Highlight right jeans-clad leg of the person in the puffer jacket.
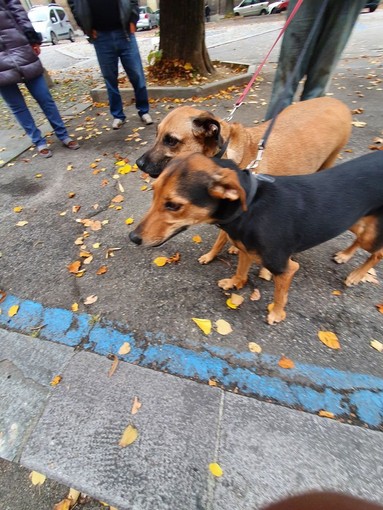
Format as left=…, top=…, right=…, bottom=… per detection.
left=25, top=75, right=69, bottom=142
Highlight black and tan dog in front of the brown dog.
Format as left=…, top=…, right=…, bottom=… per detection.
left=130, top=151, right=383, bottom=324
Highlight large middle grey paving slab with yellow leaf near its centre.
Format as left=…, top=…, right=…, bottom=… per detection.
left=21, top=352, right=222, bottom=510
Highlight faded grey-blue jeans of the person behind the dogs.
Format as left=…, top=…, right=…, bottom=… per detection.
left=265, top=0, right=366, bottom=120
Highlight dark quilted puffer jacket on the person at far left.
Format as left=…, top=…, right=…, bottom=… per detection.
left=0, top=0, right=44, bottom=87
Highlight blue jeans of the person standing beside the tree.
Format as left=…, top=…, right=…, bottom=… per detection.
left=93, top=30, right=149, bottom=120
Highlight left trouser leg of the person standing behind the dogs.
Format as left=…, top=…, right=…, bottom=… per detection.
left=265, top=0, right=321, bottom=120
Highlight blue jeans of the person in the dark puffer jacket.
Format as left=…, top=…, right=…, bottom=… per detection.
left=0, top=75, right=69, bottom=147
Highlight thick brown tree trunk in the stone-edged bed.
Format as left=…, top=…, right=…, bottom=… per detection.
left=160, top=0, right=215, bottom=76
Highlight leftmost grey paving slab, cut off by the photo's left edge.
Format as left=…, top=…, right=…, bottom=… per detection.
left=0, top=329, right=73, bottom=460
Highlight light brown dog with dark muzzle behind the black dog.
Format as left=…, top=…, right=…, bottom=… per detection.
left=137, top=97, right=352, bottom=268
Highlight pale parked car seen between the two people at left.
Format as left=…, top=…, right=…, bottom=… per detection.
left=28, top=4, right=74, bottom=44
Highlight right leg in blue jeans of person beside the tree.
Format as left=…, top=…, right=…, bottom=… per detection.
left=118, top=31, right=149, bottom=117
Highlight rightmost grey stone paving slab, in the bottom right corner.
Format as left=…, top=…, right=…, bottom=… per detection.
left=213, top=392, right=383, bottom=510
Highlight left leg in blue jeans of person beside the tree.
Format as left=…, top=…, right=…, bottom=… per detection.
left=94, top=31, right=126, bottom=121
